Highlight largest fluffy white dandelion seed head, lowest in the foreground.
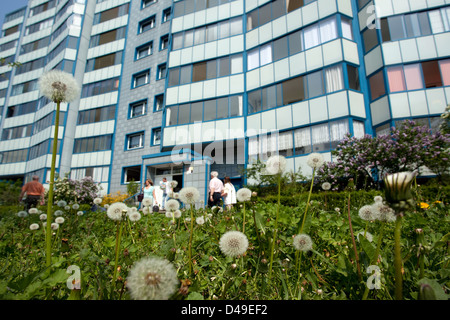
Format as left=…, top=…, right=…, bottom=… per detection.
left=126, top=257, right=179, bottom=300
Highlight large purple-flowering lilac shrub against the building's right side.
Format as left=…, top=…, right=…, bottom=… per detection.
left=316, top=120, right=450, bottom=190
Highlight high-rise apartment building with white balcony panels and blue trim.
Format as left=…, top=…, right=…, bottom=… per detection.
left=0, top=0, right=450, bottom=206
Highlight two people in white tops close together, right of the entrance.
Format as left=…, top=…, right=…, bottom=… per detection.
left=208, top=171, right=236, bottom=210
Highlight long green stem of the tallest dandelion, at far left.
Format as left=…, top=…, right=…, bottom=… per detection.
left=45, top=101, right=60, bottom=267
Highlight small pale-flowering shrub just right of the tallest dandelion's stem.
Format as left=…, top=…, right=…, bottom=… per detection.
left=54, top=176, right=101, bottom=204
